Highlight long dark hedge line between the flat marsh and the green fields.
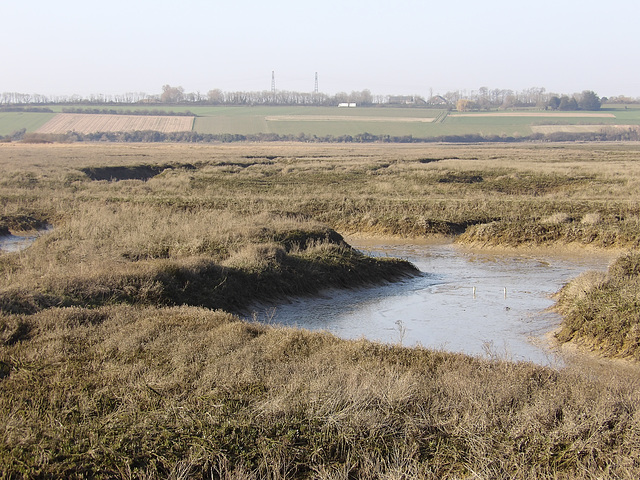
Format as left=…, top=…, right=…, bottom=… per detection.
left=11, top=127, right=640, bottom=143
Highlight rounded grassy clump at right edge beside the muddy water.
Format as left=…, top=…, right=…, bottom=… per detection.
left=557, top=253, right=640, bottom=361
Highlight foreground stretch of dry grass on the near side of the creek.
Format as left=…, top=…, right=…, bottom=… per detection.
left=0, top=305, right=640, bottom=479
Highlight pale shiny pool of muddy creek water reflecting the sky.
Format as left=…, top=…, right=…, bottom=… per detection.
left=246, top=242, right=607, bottom=364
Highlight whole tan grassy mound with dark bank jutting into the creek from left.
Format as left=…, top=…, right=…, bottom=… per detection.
left=0, top=207, right=418, bottom=313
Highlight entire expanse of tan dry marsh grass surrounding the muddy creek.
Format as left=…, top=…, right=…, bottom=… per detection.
left=0, top=144, right=640, bottom=479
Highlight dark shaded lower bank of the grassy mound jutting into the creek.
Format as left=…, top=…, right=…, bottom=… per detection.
left=0, top=243, right=418, bottom=313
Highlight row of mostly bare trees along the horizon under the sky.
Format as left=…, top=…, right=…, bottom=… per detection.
left=0, top=85, right=640, bottom=110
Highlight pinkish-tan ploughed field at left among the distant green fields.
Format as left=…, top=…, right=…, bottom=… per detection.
left=36, top=113, right=193, bottom=133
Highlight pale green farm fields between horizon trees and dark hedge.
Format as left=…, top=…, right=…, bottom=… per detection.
left=0, top=105, right=640, bottom=138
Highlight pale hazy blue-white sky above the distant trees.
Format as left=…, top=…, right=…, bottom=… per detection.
left=5, top=0, right=640, bottom=97
